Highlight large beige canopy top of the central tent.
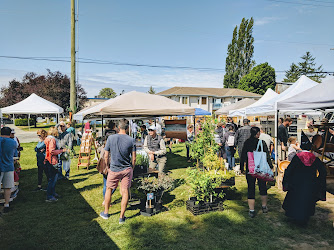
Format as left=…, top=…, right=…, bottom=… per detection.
left=74, top=91, right=195, bottom=120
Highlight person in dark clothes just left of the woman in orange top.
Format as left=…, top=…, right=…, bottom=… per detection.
left=34, top=129, right=48, bottom=191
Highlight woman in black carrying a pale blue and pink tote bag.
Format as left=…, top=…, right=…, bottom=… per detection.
left=240, top=127, right=274, bottom=218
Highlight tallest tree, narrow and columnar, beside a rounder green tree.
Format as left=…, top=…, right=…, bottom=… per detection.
left=224, top=17, right=255, bottom=88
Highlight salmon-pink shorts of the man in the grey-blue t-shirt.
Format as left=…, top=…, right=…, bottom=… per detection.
left=107, top=167, right=133, bottom=189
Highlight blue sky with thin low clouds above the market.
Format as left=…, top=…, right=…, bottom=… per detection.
left=0, top=0, right=334, bottom=97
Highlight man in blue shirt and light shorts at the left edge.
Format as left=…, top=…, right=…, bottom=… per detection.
left=0, top=127, right=17, bottom=213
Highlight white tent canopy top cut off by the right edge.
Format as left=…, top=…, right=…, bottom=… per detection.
left=277, top=79, right=334, bottom=111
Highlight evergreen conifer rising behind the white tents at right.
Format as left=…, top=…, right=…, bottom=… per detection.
left=283, top=51, right=326, bottom=82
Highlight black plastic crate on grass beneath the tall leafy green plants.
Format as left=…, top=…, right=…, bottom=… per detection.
left=186, top=197, right=224, bottom=215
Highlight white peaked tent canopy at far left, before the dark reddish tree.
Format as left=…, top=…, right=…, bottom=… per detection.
left=1, top=93, right=64, bottom=114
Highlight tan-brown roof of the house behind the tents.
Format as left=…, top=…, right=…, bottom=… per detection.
left=158, top=87, right=261, bottom=97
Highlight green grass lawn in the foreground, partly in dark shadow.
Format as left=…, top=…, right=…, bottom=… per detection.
left=0, top=143, right=334, bottom=249
